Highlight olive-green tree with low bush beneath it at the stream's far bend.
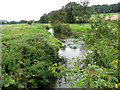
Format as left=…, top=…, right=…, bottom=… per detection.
left=49, top=7, right=71, bottom=34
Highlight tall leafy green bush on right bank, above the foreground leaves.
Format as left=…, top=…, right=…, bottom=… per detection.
left=85, top=16, right=118, bottom=68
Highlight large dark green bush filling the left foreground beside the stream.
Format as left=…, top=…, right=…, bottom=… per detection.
left=2, top=34, right=60, bottom=89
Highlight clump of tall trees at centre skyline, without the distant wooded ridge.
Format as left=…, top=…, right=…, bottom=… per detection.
left=40, top=2, right=90, bottom=23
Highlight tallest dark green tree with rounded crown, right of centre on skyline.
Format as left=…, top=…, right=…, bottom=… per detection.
left=65, top=0, right=90, bottom=23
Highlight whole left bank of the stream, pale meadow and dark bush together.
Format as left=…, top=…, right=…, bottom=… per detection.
left=2, top=24, right=61, bottom=89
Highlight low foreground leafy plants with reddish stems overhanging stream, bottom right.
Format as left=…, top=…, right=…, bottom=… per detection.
left=49, top=59, right=118, bottom=88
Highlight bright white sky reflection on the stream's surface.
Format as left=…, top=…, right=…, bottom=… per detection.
left=53, top=34, right=86, bottom=88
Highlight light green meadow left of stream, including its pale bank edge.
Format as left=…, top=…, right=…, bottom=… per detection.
left=2, top=24, right=59, bottom=44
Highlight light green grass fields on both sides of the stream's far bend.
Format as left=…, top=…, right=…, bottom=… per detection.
left=2, top=24, right=90, bottom=38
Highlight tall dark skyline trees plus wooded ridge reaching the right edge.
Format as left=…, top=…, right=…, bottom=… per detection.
left=39, top=2, right=120, bottom=23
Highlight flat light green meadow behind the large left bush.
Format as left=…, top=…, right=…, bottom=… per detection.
left=2, top=24, right=48, bottom=41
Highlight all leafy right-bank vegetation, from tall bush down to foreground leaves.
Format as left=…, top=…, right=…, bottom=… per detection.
left=50, top=16, right=120, bottom=88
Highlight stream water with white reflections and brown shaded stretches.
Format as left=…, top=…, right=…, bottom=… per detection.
left=48, top=29, right=90, bottom=88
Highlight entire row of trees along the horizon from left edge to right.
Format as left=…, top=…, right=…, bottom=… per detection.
left=0, top=2, right=120, bottom=24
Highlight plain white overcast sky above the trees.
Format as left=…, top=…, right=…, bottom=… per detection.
left=0, top=0, right=120, bottom=21
